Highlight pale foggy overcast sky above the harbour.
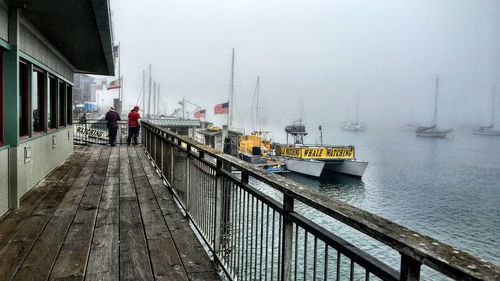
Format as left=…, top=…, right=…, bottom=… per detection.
left=104, top=0, right=500, bottom=129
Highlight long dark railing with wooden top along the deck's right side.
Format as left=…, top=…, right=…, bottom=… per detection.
left=142, top=122, right=500, bottom=280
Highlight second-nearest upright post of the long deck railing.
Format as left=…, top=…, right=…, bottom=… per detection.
left=281, top=194, right=294, bottom=281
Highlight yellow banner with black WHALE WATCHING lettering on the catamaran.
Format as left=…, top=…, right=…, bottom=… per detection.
left=276, top=147, right=354, bottom=159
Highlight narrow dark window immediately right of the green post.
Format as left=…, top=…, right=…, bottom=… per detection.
left=19, top=61, right=29, bottom=137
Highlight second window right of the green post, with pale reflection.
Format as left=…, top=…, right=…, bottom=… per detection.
left=31, top=68, right=46, bottom=133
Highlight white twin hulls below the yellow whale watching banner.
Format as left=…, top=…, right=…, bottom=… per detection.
left=285, top=159, right=368, bottom=177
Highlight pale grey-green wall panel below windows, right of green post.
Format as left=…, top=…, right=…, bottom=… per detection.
left=17, top=127, right=73, bottom=199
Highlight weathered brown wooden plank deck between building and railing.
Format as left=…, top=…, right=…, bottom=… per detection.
left=0, top=146, right=219, bottom=281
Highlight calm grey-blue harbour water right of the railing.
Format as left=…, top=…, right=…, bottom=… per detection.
left=264, top=130, right=500, bottom=276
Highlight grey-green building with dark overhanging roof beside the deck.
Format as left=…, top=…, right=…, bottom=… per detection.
left=0, top=0, right=114, bottom=216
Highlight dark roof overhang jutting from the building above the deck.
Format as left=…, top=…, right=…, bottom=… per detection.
left=7, top=0, right=115, bottom=75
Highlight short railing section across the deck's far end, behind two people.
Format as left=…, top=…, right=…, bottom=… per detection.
left=73, top=119, right=142, bottom=144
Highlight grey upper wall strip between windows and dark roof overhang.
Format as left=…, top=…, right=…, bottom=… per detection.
left=19, top=19, right=74, bottom=82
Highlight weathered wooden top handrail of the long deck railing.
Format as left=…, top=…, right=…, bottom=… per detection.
left=142, top=122, right=500, bottom=280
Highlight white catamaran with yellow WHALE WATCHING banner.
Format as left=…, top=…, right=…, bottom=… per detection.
left=276, top=123, right=368, bottom=178
